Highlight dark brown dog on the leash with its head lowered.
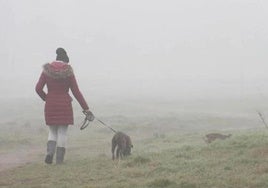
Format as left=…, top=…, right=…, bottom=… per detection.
left=112, top=132, right=133, bottom=160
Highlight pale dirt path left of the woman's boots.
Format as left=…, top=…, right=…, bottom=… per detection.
left=0, top=147, right=43, bottom=172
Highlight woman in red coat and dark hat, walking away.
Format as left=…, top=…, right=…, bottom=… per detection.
left=35, top=48, right=94, bottom=164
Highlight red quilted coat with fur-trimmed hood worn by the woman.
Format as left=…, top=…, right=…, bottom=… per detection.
left=35, top=61, right=88, bottom=125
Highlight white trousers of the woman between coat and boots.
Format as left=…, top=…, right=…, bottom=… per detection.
left=48, top=125, right=68, bottom=148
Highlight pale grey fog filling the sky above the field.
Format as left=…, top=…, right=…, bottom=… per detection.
left=0, top=0, right=268, bottom=103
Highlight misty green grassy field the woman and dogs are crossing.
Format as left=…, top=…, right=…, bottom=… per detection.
left=0, top=97, right=268, bottom=188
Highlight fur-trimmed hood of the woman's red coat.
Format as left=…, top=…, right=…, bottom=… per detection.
left=43, top=61, right=73, bottom=79
